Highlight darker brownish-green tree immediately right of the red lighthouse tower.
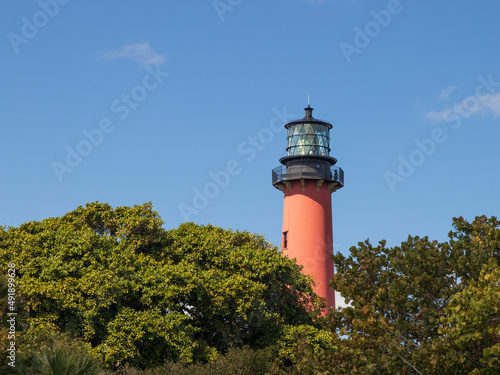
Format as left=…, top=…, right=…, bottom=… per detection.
left=326, top=237, right=458, bottom=374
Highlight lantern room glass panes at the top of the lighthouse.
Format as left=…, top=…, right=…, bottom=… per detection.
left=287, top=123, right=330, bottom=156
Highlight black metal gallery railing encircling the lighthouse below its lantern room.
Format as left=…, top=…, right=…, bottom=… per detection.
left=273, top=165, right=344, bottom=186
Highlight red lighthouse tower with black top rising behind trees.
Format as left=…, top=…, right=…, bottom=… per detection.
left=273, top=105, right=344, bottom=307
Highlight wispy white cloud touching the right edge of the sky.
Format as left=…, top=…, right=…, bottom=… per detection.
left=424, top=93, right=500, bottom=122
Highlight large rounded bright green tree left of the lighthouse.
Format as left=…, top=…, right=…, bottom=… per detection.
left=0, top=202, right=321, bottom=368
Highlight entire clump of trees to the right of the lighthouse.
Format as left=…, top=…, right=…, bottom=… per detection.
left=276, top=216, right=500, bottom=374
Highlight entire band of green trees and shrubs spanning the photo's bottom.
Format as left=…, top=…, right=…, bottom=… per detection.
left=0, top=202, right=500, bottom=375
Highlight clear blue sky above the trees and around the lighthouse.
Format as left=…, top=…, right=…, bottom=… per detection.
left=0, top=0, right=500, bottom=253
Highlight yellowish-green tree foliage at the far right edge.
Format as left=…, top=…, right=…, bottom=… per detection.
left=426, top=216, right=500, bottom=374
